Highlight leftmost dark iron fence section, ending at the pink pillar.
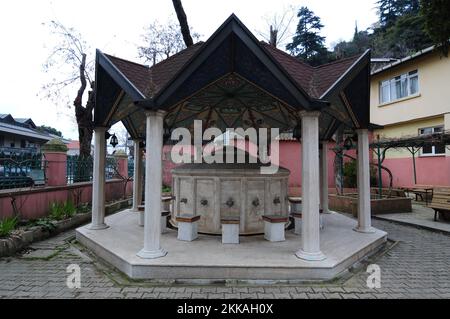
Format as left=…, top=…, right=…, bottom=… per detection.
left=0, top=152, right=46, bottom=189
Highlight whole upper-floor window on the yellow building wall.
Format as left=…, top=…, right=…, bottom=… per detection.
left=380, top=70, right=419, bottom=104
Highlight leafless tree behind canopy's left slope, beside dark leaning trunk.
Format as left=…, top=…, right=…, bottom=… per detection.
left=138, top=19, right=200, bottom=65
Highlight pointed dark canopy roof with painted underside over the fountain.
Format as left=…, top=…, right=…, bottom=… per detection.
left=94, top=15, right=370, bottom=139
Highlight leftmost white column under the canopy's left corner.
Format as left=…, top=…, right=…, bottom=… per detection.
left=89, top=127, right=108, bottom=230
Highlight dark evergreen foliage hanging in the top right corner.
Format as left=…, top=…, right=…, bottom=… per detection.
left=421, top=0, right=450, bottom=56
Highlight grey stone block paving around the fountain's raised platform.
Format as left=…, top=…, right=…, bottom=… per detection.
left=0, top=220, right=450, bottom=299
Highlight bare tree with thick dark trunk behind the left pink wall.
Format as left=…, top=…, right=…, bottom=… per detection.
left=42, top=21, right=95, bottom=157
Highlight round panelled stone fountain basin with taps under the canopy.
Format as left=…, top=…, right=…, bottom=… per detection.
left=171, top=163, right=290, bottom=235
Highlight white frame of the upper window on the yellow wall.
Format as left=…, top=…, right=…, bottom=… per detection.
left=378, top=69, right=420, bottom=104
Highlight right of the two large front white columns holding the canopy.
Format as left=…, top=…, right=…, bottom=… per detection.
left=296, top=112, right=326, bottom=261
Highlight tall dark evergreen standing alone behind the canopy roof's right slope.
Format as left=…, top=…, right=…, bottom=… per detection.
left=286, top=7, right=328, bottom=64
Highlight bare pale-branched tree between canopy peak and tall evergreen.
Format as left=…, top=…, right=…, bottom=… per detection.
left=257, top=6, right=296, bottom=47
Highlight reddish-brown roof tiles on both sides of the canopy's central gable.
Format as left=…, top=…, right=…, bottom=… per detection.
left=106, top=42, right=361, bottom=98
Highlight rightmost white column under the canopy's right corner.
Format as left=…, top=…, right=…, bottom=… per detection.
left=355, top=129, right=374, bottom=233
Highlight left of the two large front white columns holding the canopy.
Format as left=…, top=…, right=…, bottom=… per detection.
left=138, top=111, right=167, bottom=259
